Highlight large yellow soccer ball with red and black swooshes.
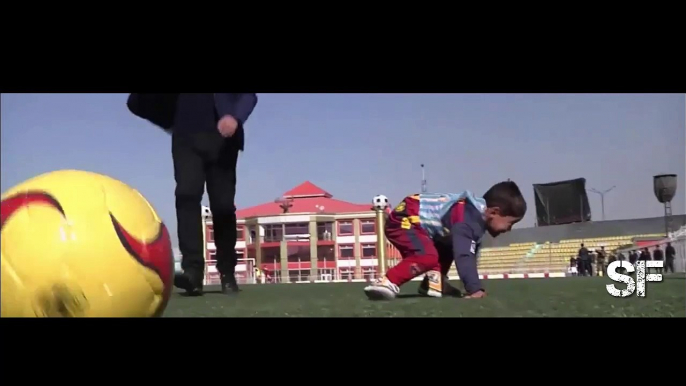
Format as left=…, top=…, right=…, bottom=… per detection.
left=0, top=170, right=174, bottom=317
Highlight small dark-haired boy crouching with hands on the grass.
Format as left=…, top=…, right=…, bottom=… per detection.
left=364, top=181, right=526, bottom=300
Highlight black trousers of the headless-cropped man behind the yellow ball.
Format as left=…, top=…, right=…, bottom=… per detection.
left=172, top=130, right=239, bottom=275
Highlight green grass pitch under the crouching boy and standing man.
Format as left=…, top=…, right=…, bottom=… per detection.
left=165, top=275, right=686, bottom=317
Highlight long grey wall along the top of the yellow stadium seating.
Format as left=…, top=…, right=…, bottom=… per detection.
left=483, top=215, right=686, bottom=248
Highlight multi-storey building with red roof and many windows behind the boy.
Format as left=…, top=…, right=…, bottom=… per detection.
left=205, top=181, right=400, bottom=282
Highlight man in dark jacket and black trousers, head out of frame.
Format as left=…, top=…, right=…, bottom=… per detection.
left=128, top=93, right=257, bottom=296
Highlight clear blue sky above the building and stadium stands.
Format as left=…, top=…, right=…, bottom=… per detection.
left=0, top=94, right=686, bottom=244
